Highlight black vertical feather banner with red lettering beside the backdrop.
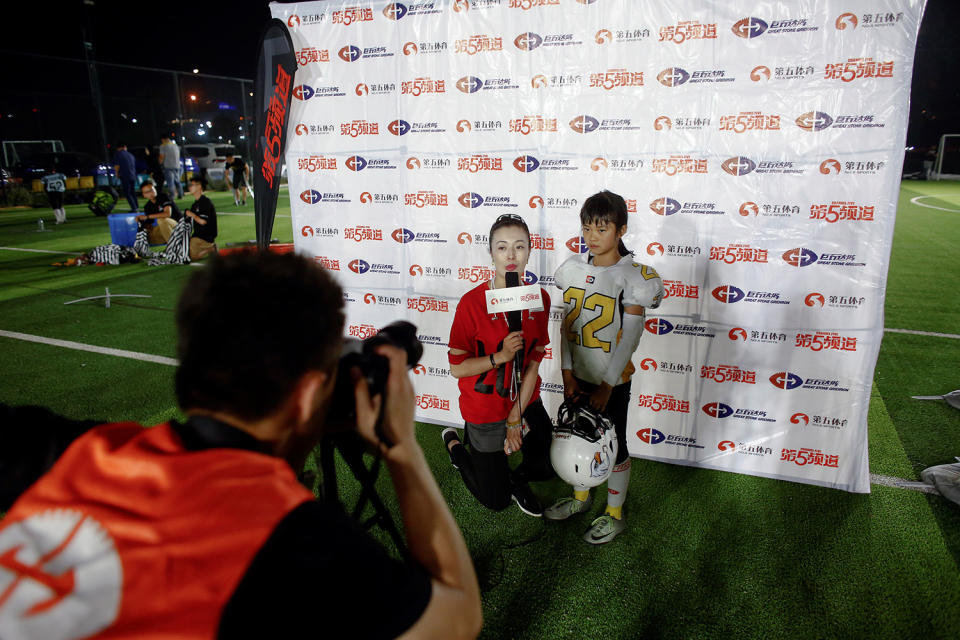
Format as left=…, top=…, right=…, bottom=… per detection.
left=252, top=18, right=297, bottom=249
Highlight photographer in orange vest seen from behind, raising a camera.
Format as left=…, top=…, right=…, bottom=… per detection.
left=0, top=253, right=481, bottom=638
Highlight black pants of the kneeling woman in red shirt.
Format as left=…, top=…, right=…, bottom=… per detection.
left=450, top=399, right=556, bottom=511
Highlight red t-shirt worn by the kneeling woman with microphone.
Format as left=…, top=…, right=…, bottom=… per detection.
left=448, top=282, right=550, bottom=424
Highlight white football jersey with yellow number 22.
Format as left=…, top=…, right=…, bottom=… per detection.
left=554, top=254, right=663, bottom=384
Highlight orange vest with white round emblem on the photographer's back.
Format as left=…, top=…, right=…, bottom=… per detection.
left=0, top=423, right=313, bottom=640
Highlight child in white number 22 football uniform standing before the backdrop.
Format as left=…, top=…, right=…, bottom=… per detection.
left=544, top=191, right=663, bottom=544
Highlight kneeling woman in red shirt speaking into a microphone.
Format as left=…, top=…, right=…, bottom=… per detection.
left=442, top=214, right=554, bottom=517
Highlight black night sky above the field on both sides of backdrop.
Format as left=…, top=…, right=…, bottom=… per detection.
left=0, top=0, right=960, bottom=151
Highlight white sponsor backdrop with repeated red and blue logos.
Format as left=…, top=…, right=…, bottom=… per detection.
left=271, top=0, right=924, bottom=492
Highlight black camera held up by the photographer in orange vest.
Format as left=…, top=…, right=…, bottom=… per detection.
left=328, top=320, right=423, bottom=446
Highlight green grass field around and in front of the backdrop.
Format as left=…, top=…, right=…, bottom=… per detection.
left=0, top=182, right=960, bottom=640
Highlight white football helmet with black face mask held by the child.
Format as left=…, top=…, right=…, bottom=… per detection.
left=550, top=400, right=617, bottom=487
